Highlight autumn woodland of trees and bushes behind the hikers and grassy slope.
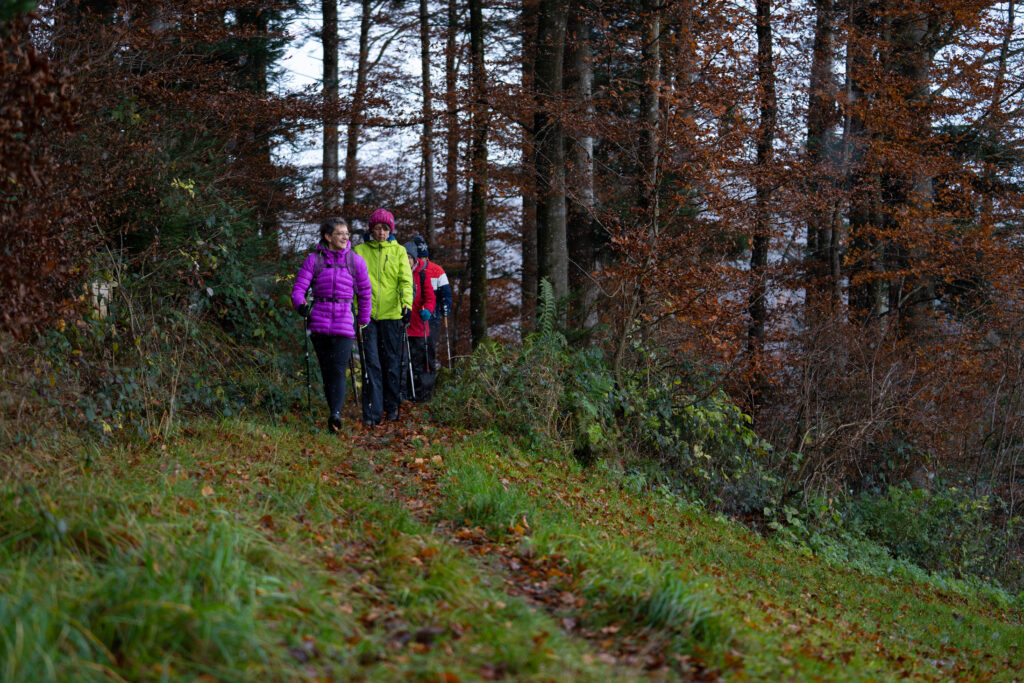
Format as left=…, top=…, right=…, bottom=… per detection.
left=0, top=0, right=1024, bottom=585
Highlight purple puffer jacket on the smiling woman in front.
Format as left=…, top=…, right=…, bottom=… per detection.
left=292, top=243, right=371, bottom=339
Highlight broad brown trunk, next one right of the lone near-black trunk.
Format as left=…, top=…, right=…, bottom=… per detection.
left=804, top=0, right=840, bottom=321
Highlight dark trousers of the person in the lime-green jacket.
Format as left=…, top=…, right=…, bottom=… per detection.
left=362, top=319, right=406, bottom=424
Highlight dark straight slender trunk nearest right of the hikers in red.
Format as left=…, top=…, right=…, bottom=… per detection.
left=469, top=0, right=489, bottom=348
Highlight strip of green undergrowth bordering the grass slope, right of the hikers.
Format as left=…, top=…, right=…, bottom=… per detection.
left=432, top=288, right=1024, bottom=594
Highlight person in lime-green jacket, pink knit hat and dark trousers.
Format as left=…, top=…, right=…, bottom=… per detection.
left=354, top=209, right=413, bottom=427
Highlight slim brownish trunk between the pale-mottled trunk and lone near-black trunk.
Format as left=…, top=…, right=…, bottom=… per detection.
left=637, top=0, right=664, bottom=238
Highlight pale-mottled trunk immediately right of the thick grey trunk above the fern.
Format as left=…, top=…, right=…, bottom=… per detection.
left=565, top=3, right=598, bottom=327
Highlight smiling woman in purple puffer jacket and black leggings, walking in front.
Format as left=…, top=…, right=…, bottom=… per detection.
left=292, top=218, right=371, bottom=433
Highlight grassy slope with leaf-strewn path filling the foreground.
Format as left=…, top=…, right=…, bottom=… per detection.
left=0, top=409, right=1024, bottom=683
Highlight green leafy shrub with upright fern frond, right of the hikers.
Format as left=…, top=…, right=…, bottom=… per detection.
left=434, top=283, right=795, bottom=514
